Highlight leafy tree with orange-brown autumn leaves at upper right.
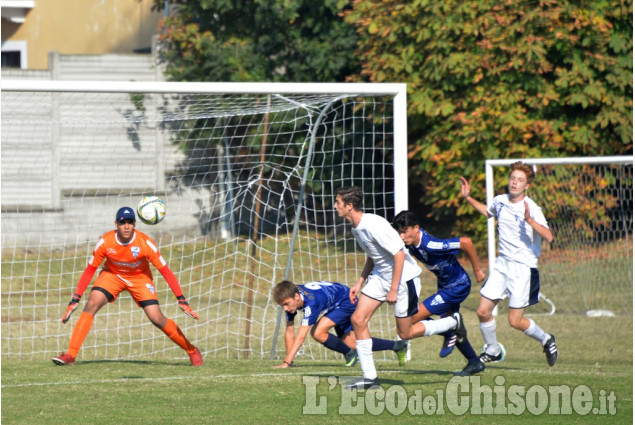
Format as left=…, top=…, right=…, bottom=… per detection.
left=346, top=0, right=633, bottom=237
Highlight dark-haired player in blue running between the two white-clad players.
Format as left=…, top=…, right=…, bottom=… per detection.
left=393, top=211, right=485, bottom=376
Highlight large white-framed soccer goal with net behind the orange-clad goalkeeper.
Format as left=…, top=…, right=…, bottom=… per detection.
left=1, top=80, right=408, bottom=360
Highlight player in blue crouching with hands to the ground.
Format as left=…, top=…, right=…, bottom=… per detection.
left=273, top=280, right=408, bottom=368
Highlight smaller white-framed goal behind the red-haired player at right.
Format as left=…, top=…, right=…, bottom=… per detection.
left=485, top=156, right=633, bottom=315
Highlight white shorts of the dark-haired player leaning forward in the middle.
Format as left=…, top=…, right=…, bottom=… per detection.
left=362, top=274, right=421, bottom=317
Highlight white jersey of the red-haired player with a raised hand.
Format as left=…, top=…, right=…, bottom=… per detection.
left=487, top=194, right=549, bottom=268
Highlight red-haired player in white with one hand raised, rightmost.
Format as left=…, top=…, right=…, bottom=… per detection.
left=461, top=161, right=558, bottom=366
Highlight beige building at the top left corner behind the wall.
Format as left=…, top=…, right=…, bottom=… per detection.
left=0, top=0, right=163, bottom=70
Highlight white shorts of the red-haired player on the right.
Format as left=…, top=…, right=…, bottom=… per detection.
left=481, top=257, right=540, bottom=308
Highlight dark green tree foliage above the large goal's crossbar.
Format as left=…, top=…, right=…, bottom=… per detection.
left=155, top=0, right=360, bottom=82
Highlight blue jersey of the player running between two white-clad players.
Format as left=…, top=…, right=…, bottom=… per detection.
left=408, top=229, right=471, bottom=289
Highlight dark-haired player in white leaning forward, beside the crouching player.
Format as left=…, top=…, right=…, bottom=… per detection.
left=334, top=187, right=466, bottom=389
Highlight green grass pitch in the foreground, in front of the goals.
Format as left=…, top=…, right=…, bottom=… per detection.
left=2, top=311, right=633, bottom=425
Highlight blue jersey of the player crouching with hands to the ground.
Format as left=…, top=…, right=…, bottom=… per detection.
left=287, top=281, right=350, bottom=326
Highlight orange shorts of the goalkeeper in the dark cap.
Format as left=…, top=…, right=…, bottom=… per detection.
left=92, top=270, right=159, bottom=308
